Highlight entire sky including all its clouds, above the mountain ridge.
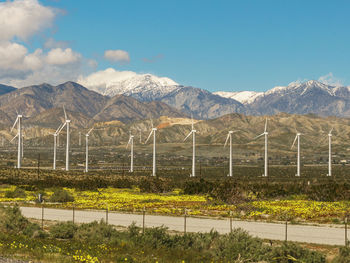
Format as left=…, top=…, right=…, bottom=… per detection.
left=0, top=0, right=350, bottom=91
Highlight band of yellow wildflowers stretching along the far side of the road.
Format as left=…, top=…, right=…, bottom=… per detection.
left=0, top=186, right=350, bottom=223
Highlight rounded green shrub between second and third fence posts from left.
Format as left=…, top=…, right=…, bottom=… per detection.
left=74, top=220, right=118, bottom=243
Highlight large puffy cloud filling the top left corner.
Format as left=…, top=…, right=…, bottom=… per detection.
left=0, top=0, right=55, bottom=41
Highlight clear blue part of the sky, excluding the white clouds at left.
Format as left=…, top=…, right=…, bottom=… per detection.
left=2, top=0, right=350, bottom=91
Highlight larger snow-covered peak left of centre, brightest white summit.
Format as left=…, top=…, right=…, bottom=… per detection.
left=78, top=68, right=180, bottom=101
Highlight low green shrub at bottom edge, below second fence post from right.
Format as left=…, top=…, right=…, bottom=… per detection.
left=269, top=243, right=326, bottom=263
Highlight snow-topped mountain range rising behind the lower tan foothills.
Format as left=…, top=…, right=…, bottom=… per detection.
left=0, top=73, right=350, bottom=128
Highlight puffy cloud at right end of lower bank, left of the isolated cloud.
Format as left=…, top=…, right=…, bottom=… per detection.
left=46, top=48, right=81, bottom=65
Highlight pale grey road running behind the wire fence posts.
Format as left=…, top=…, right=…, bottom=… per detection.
left=21, top=207, right=345, bottom=245
